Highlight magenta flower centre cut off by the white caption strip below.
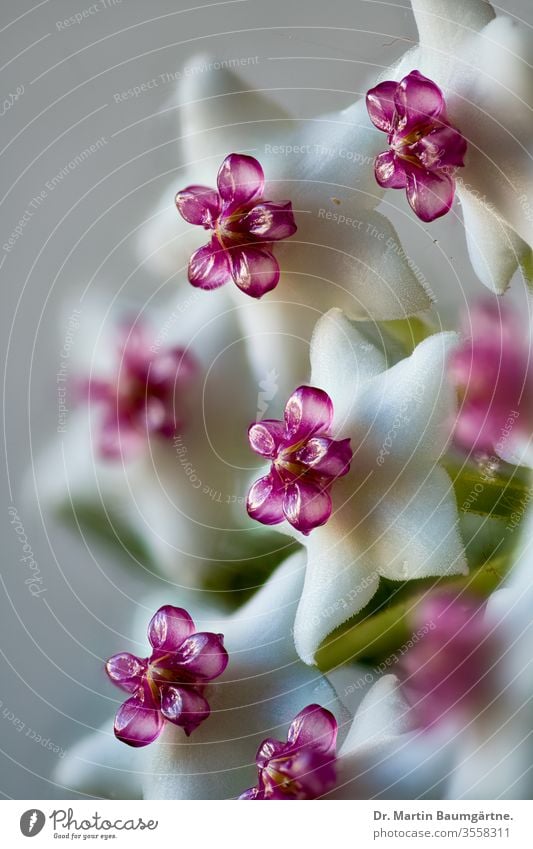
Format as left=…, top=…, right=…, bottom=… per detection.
left=239, top=705, right=338, bottom=800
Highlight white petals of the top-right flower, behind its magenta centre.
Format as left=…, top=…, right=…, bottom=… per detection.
left=382, top=0, right=533, bottom=294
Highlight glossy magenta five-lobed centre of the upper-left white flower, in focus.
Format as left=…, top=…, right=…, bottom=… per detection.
left=176, top=153, right=296, bottom=298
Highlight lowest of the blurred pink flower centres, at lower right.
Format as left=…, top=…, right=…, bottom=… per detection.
left=398, top=593, right=497, bottom=728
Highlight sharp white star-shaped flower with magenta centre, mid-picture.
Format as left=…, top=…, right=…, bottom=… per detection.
left=247, top=310, right=466, bottom=663
